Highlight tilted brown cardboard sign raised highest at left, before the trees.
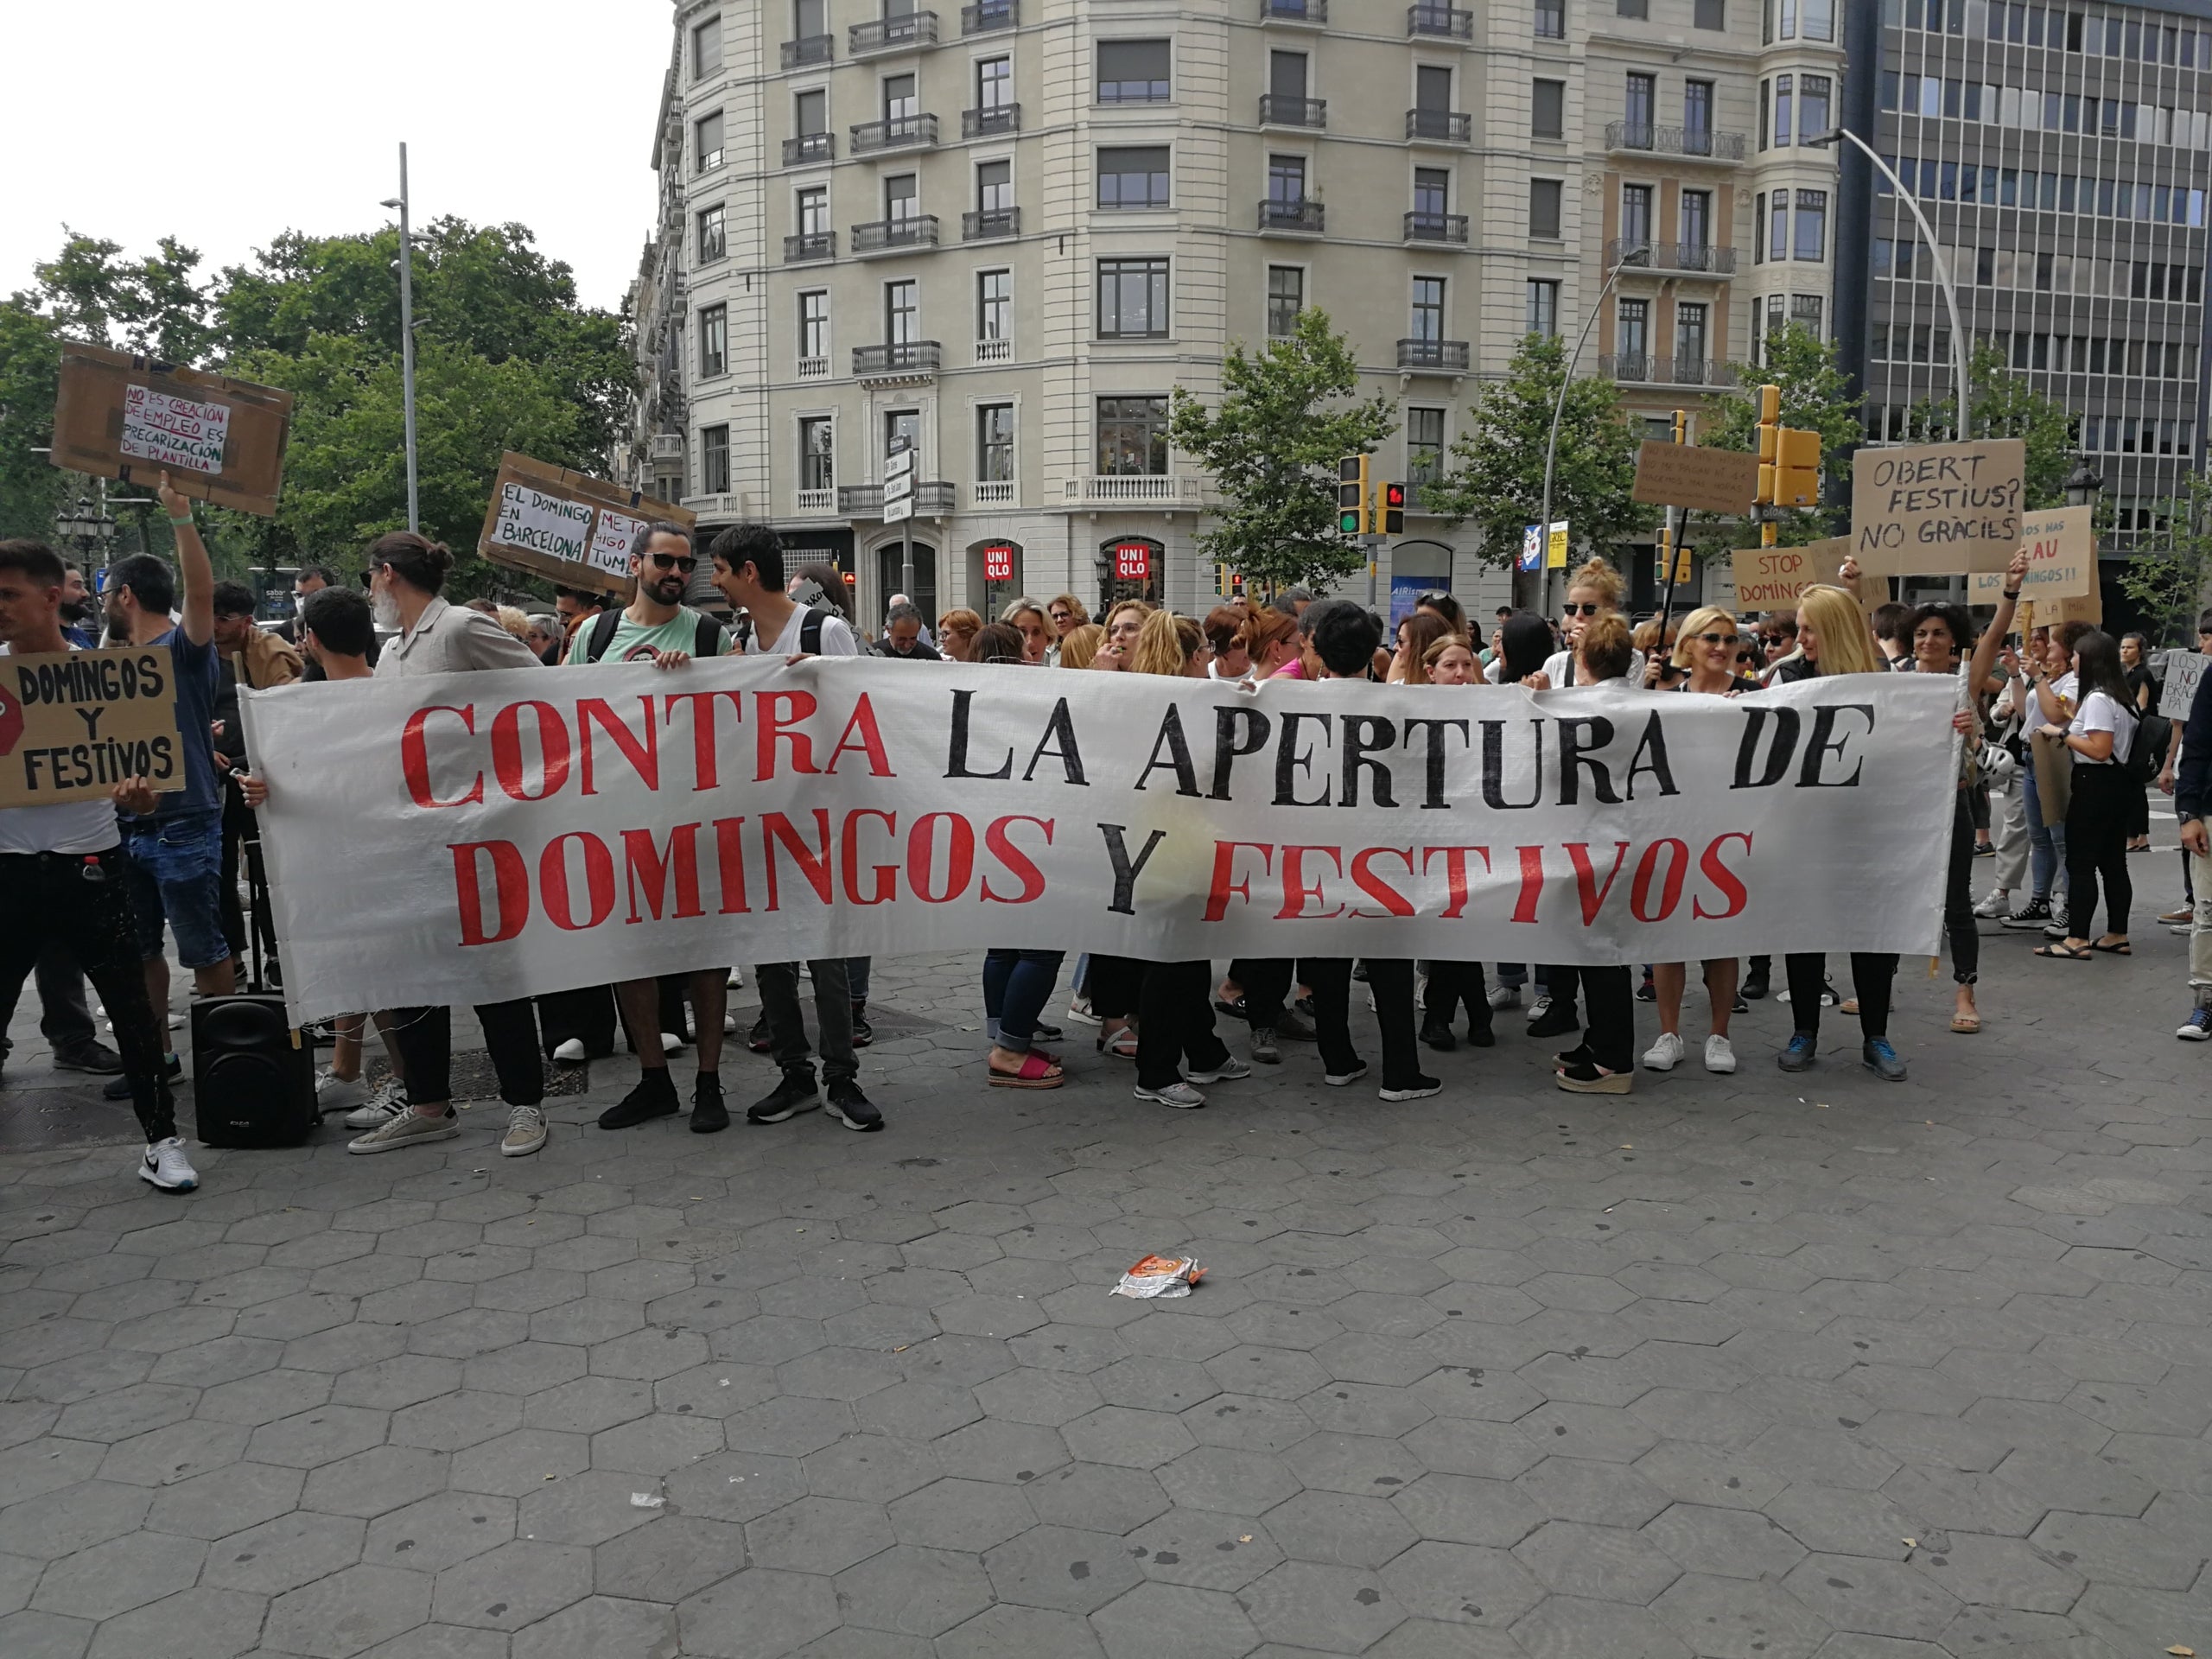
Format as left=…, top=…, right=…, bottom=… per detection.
left=48, top=345, right=292, bottom=518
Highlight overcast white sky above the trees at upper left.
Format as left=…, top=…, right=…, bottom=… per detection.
left=0, top=0, right=671, bottom=318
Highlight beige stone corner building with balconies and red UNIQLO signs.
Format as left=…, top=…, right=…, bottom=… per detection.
left=617, top=0, right=1842, bottom=621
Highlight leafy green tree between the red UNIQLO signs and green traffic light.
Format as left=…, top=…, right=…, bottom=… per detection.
left=1168, top=308, right=1398, bottom=591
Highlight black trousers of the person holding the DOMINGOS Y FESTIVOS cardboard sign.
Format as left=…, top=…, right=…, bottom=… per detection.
left=0, top=847, right=177, bottom=1141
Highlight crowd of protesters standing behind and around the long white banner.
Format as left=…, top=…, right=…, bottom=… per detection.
left=0, top=493, right=2212, bottom=1190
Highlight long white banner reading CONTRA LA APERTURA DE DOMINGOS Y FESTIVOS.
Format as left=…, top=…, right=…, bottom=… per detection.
left=241, top=657, right=1958, bottom=1020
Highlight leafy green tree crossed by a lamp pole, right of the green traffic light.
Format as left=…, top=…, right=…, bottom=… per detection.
left=1422, top=334, right=1659, bottom=566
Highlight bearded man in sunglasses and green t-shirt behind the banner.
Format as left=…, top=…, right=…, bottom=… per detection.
left=566, top=524, right=730, bottom=1135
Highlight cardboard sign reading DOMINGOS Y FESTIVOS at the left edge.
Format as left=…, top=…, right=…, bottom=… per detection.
left=0, top=646, right=183, bottom=807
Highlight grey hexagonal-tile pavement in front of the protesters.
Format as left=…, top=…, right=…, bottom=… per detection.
left=0, top=849, right=2212, bottom=1659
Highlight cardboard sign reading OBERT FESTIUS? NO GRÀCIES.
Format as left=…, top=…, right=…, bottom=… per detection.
left=1852, top=438, right=2029, bottom=575
